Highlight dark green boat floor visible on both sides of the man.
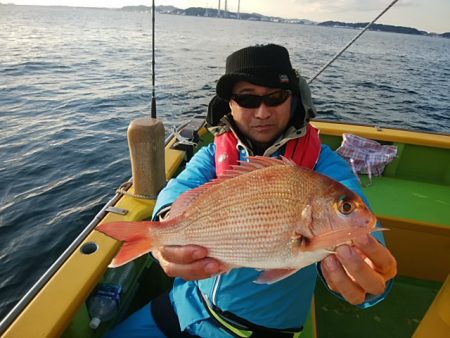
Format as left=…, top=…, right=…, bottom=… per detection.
left=68, top=264, right=442, bottom=338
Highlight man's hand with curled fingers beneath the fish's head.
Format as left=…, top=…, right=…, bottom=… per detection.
left=321, top=235, right=397, bottom=305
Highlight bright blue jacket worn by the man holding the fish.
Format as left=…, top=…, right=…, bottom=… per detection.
left=154, top=144, right=389, bottom=335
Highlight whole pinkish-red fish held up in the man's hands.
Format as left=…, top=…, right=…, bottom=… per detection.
left=97, top=157, right=376, bottom=283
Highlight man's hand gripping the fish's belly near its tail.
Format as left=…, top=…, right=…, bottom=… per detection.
left=152, top=245, right=226, bottom=280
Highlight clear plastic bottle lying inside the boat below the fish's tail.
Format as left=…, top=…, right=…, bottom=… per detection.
left=88, top=262, right=135, bottom=329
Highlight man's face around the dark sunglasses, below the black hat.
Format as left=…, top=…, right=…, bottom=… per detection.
left=230, top=81, right=292, bottom=146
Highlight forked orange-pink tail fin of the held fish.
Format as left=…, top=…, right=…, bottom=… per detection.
left=96, top=222, right=157, bottom=268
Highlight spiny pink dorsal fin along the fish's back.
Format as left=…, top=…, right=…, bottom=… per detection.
left=169, top=156, right=295, bottom=218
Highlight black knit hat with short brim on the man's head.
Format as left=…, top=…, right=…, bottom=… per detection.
left=216, top=44, right=299, bottom=101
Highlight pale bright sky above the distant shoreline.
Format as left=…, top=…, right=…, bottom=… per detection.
left=5, top=0, right=450, bottom=33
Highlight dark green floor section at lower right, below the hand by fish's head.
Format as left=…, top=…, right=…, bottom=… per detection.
left=315, top=277, right=442, bottom=338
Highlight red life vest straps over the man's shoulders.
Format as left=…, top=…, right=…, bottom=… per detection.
left=214, top=124, right=321, bottom=177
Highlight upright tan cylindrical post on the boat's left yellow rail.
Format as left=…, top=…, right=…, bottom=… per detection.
left=128, top=117, right=166, bottom=197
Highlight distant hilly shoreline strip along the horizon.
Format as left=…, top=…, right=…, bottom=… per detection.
left=0, top=2, right=450, bottom=39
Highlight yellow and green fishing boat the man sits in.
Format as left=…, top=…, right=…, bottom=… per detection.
left=0, top=118, right=450, bottom=338
